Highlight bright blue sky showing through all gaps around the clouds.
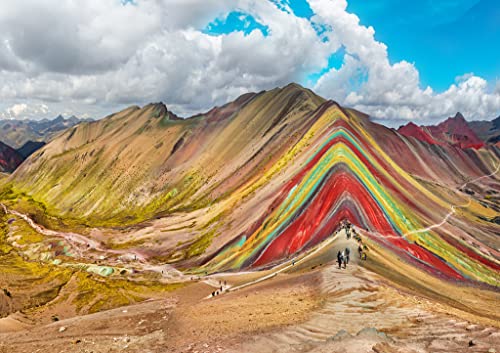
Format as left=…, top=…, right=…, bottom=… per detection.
left=204, top=0, right=500, bottom=91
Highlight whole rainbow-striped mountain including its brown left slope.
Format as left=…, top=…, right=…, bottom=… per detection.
left=2, top=84, right=500, bottom=286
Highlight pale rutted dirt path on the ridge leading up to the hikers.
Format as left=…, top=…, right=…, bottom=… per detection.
left=234, top=231, right=500, bottom=353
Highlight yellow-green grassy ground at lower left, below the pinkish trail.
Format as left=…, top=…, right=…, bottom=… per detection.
left=0, top=211, right=185, bottom=317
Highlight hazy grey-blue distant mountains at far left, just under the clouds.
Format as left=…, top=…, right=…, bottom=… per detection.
left=0, top=115, right=90, bottom=149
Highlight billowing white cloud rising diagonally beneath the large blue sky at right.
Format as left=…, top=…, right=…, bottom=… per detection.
left=309, top=0, right=500, bottom=120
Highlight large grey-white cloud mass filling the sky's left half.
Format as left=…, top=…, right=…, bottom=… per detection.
left=0, top=0, right=338, bottom=114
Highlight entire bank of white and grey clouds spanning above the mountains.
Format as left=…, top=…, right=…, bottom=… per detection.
left=0, top=0, right=500, bottom=119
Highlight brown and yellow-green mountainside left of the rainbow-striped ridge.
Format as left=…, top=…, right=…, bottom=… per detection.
left=9, top=85, right=324, bottom=223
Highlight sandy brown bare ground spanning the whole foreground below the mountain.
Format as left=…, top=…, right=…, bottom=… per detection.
left=0, top=232, right=500, bottom=353
